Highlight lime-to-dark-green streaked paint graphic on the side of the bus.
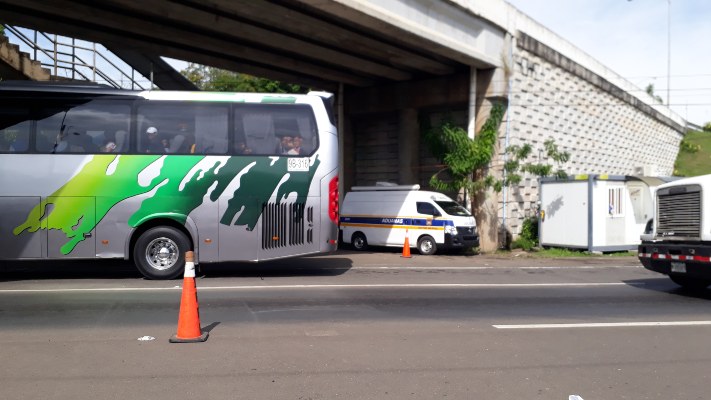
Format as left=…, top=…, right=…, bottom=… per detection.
left=13, top=155, right=319, bottom=255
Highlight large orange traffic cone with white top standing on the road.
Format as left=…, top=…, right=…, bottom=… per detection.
left=169, top=251, right=209, bottom=343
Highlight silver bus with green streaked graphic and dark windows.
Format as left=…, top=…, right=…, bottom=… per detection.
left=0, top=82, right=338, bottom=279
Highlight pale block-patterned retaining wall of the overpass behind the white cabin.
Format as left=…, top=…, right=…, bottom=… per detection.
left=497, top=33, right=684, bottom=236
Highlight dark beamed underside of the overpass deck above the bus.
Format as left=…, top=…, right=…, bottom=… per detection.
left=0, top=0, right=500, bottom=91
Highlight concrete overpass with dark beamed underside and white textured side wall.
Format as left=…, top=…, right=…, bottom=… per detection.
left=0, top=0, right=685, bottom=249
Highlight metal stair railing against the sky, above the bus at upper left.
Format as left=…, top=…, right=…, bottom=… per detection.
left=3, top=25, right=152, bottom=90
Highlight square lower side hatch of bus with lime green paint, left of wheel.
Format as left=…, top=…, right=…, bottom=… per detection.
left=47, top=197, right=96, bottom=258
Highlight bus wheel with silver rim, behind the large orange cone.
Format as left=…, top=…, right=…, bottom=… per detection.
left=133, top=226, right=190, bottom=279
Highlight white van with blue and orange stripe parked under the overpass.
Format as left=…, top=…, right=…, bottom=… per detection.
left=340, top=184, right=479, bottom=255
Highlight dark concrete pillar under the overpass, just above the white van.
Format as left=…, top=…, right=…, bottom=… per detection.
left=398, top=108, right=420, bottom=185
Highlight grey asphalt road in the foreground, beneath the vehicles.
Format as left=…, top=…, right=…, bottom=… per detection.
left=0, top=251, right=711, bottom=400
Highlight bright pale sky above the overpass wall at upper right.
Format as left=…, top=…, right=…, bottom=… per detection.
left=507, top=0, right=711, bottom=126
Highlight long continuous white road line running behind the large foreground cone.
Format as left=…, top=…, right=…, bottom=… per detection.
left=0, top=282, right=644, bottom=294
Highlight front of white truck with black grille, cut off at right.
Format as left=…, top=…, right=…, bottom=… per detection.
left=638, top=175, right=711, bottom=289
